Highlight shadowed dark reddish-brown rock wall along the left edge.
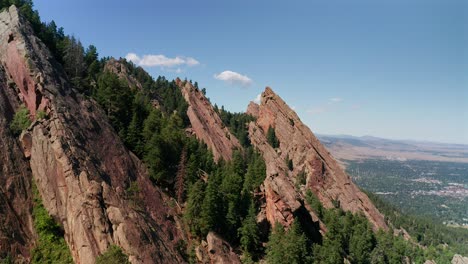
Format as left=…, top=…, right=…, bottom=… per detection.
left=0, top=64, right=35, bottom=261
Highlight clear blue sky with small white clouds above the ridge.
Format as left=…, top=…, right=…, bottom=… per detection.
left=34, top=0, right=468, bottom=144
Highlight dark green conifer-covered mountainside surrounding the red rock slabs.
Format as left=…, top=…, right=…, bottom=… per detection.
left=0, top=0, right=468, bottom=264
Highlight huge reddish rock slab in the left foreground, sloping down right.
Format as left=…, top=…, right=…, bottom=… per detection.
left=0, top=7, right=183, bottom=263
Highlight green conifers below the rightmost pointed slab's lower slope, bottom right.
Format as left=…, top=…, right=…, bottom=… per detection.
left=306, top=190, right=438, bottom=264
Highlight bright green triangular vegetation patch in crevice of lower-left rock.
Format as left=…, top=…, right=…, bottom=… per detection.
left=31, top=185, right=73, bottom=264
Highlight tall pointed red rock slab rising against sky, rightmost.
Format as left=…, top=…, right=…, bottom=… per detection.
left=247, top=87, right=387, bottom=229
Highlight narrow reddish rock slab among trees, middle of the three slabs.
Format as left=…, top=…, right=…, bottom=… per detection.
left=176, top=78, right=242, bottom=161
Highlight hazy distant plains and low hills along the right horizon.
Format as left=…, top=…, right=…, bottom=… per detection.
left=317, top=134, right=468, bottom=163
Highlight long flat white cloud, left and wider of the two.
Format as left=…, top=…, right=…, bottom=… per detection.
left=125, top=53, right=200, bottom=68
